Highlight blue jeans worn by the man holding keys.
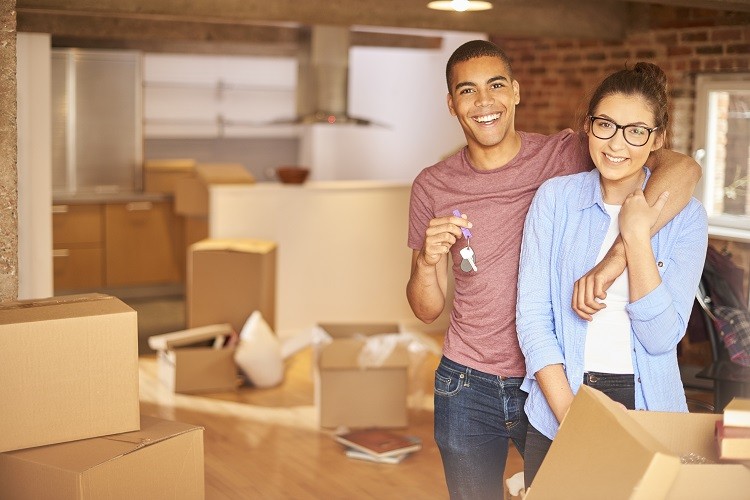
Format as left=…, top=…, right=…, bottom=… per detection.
left=435, top=356, right=528, bottom=500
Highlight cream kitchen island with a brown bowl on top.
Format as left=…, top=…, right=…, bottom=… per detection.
left=209, top=181, right=444, bottom=332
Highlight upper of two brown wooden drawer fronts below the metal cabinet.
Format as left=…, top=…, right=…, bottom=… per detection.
left=52, top=204, right=104, bottom=248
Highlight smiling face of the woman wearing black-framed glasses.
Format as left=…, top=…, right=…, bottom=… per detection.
left=587, top=94, right=664, bottom=189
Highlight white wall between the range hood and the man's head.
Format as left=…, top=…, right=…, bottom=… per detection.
left=300, top=32, right=486, bottom=182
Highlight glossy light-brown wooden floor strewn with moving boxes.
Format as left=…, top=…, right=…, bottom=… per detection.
left=140, top=340, right=523, bottom=500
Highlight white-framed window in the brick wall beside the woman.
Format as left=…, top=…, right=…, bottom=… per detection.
left=694, top=74, right=750, bottom=234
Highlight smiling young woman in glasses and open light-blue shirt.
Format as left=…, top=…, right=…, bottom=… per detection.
left=516, top=62, right=708, bottom=486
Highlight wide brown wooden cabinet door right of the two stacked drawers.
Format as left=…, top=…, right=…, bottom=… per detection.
left=105, top=201, right=184, bottom=286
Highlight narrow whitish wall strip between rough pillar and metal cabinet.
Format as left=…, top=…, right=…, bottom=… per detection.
left=16, top=33, right=53, bottom=299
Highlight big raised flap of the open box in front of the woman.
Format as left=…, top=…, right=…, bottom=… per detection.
left=526, top=385, right=680, bottom=500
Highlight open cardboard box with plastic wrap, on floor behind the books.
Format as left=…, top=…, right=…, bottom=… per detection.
left=314, top=323, right=409, bottom=428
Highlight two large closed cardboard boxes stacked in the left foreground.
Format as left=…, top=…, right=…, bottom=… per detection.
left=0, top=294, right=204, bottom=500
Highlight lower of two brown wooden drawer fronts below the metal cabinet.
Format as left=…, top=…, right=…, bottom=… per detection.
left=52, top=248, right=104, bottom=291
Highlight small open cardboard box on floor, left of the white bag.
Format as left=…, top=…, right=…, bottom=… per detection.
left=148, top=323, right=239, bottom=394
